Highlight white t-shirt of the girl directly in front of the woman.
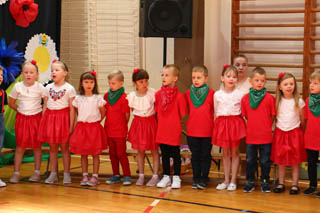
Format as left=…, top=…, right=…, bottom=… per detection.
left=213, top=89, right=244, bottom=117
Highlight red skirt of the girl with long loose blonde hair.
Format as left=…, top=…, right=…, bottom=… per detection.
left=271, top=127, right=307, bottom=166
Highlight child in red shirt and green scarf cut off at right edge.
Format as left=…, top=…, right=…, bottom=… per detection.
left=303, top=71, right=320, bottom=197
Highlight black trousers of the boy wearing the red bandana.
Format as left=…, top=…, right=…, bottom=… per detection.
left=160, top=144, right=181, bottom=176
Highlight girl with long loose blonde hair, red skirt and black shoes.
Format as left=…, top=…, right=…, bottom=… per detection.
left=271, top=73, right=306, bottom=195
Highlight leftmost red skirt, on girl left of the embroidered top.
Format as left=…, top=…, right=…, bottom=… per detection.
left=15, top=112, right=42, bottom=148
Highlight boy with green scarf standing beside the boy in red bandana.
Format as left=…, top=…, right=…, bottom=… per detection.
left=185, top=66, right=214, bottom=189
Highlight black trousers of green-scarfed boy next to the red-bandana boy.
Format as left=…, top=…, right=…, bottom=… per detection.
left=187, top=136, right=212, bottom=184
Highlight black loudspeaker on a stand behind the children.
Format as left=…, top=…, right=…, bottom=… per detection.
left=139, top=0, right=193, bottom=38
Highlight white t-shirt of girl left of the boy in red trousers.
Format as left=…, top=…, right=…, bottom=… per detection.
left=72, top=95, right=107, bottom=123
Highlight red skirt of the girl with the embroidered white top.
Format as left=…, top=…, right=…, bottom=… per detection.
left=38, top=107, right=70, bottom=144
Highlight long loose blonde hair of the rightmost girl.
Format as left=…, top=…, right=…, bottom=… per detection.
left=276, top=73, right=300, bottom=114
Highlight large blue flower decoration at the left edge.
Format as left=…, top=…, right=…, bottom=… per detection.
left=0, top=38, right=24, bottom=85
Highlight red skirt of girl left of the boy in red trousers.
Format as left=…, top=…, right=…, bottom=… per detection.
left=70, top=122, right=108, bottom=155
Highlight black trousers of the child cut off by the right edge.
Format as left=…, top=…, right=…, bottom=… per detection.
left=307, top=149, right=319, bottom=188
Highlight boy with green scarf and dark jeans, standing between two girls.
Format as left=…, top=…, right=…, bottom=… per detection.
left=241, top=67, right=276, bottom=192
